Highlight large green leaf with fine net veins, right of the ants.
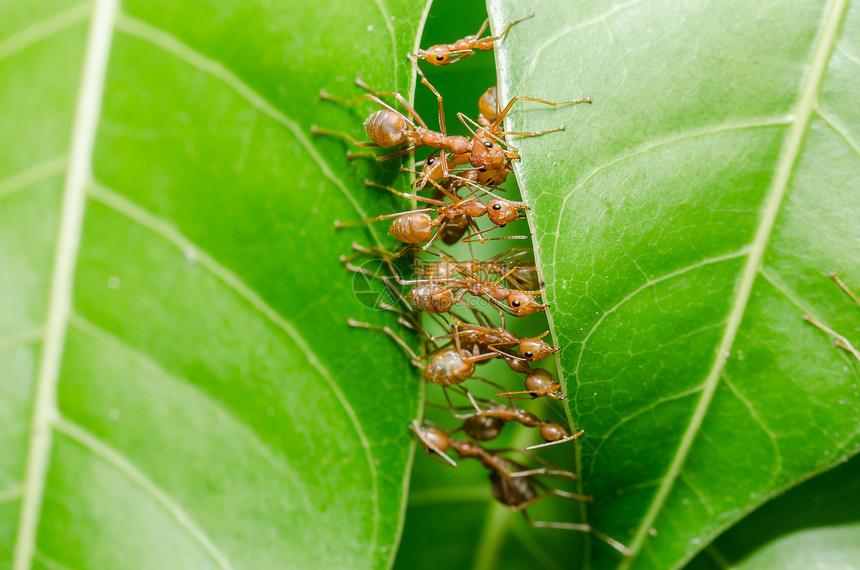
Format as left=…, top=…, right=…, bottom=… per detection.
left=490, top=0, right=860, bottom=568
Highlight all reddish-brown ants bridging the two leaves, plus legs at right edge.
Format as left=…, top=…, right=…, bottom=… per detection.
left=311, top=8, right=860, bottom=556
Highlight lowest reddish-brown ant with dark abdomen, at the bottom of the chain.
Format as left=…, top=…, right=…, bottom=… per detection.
left=410, top=421, right=630, bottom=556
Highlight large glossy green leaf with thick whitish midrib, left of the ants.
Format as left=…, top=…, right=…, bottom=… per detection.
left=0, top=0, right=424, bottom=569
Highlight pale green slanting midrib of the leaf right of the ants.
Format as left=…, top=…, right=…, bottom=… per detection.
left=618, top=0, right=848, bottom=570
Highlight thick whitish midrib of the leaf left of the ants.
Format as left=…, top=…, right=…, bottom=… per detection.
left=13, top=0, right=118, bottom=570
